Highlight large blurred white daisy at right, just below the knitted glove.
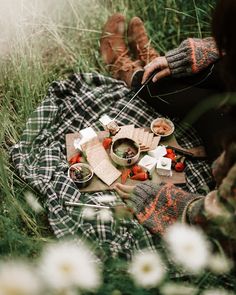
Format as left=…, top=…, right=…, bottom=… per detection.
left=164, top=223, right=210, bottom=273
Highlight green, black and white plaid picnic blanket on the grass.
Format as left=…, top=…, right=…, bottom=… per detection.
left=11, top=73, right=214, bottom=258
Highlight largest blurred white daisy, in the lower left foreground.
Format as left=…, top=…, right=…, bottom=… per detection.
left=39, top=241, right=101, bottom=290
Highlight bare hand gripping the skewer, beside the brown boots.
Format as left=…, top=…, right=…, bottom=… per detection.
left=142, top=56, right=171, bottom=84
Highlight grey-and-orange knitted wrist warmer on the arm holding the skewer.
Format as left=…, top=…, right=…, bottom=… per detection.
left=165, top=37, right=220, bottom=77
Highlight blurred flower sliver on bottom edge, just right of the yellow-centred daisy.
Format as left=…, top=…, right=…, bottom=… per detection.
left=161, top=283, right=198, bottom=295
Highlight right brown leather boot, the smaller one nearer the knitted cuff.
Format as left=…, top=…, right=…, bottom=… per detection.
left=128, top=16, right=159, bottom=65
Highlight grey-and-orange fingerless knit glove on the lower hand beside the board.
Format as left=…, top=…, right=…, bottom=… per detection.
left=132, top=181, right=201, bottom=234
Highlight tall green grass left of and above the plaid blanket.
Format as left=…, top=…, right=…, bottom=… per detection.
left=0, top=0, right=215, bottom=266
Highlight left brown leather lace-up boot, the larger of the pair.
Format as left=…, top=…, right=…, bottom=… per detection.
left=100, top=13, right=143, bottom=87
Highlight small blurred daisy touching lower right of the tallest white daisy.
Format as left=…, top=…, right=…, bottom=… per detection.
left=208, top=254, right=233, bottom=274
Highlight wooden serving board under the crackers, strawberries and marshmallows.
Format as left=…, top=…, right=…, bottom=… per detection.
left=66, top=131, right=205, bottom=192
